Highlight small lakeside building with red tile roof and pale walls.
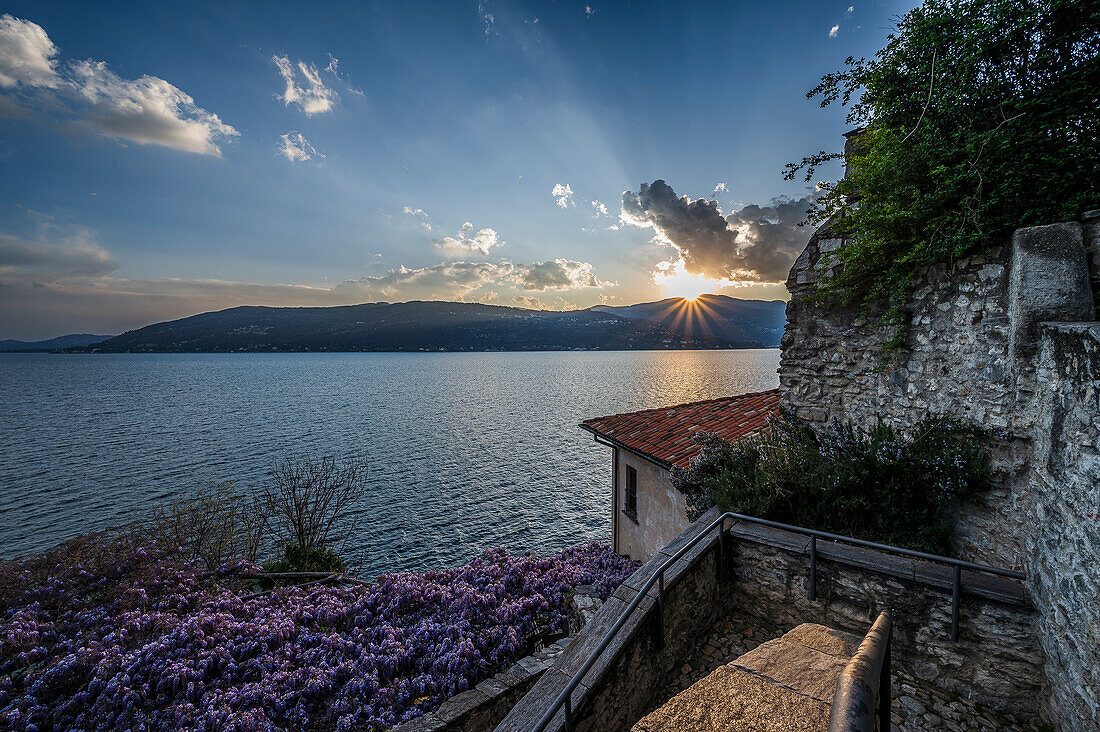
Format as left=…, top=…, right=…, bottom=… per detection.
left=581, top=389, right=779, bottom=561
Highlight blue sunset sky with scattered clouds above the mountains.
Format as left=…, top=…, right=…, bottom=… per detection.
left=0, top=0, right=913, bottom=340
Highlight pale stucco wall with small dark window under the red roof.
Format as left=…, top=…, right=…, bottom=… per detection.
left=615, top=448, right=689, bottom=561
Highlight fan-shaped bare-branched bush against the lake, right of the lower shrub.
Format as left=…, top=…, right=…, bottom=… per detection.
left=260, top=457, right=366, bottom=550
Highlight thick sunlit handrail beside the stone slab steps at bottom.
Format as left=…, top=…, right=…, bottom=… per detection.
left=828, top=611, right=893, bottom=732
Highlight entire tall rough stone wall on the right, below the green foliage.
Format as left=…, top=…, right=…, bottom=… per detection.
left=780, top=211, right=1100, bottom=730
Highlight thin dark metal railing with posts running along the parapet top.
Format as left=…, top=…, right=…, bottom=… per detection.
left=531, top=512, right=1026, bottom=732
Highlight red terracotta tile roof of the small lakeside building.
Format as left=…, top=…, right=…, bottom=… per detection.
left=581, top=389, right=779, bottom=468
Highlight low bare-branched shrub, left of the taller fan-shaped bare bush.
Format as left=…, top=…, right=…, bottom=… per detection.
left=136, top=483, right=267, bottom=570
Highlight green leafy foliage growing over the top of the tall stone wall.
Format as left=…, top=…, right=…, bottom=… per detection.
left=787, top=0, right=1100, bottom=325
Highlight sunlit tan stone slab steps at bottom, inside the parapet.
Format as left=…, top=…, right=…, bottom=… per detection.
left=633, top=623, right=862, bottom=732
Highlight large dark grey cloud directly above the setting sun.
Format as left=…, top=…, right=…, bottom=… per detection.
left=622, top=181, right=810, bottom=282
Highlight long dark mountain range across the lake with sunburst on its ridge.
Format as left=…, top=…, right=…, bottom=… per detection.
left=62, top=295, right=785, bottom=353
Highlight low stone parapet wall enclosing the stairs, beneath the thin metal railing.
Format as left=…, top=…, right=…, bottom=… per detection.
left=496, top=509, right=1043, bottom=732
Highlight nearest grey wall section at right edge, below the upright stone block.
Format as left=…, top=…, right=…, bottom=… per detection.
left=1027, top=324, right=1100, bottom=730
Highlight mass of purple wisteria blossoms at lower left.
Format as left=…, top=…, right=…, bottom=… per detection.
left=0, top=536, right=636, bottom=732
